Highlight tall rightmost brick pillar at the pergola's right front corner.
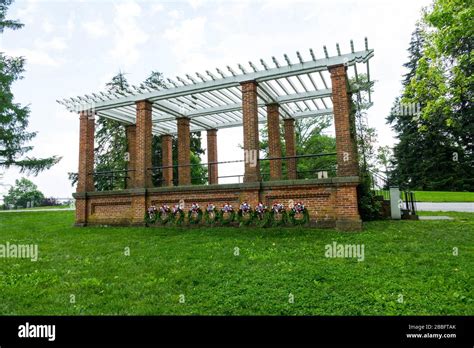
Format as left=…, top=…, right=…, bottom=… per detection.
left=329, top=64, right=359, bottom=176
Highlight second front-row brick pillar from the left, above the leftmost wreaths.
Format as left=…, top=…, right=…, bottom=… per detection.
left=135, top=100, right=152, bottom=188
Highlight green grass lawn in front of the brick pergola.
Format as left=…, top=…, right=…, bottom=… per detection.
left=0, top=212, right=474, bottom=315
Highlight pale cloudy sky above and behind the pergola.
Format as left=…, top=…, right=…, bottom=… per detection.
left=0, top=0, right=431, bottom=198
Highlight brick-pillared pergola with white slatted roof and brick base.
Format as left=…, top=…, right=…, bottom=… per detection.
left=59, top=39, right=373, bottom=230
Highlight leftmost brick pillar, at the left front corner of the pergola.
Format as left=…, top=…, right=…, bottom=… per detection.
left=76, top=111, right=95, bottom=192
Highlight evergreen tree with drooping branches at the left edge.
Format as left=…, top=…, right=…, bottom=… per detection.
left=0, top=0, right=60, bottom=175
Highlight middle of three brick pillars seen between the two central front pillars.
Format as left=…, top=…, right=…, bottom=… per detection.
left=177, top=117, right=191, bottom=185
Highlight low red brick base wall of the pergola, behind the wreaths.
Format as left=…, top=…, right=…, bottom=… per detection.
left=76, top=177, right=362, bottom=231
